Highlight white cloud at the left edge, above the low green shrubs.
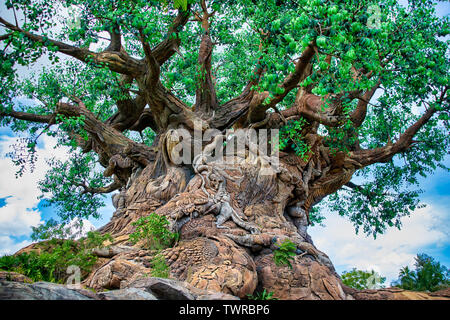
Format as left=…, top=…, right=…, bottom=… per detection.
left=0, top=136, right=67, bottom=253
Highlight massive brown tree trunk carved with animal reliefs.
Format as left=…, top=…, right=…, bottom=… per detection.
left=85, top=126, right=353, bottom=299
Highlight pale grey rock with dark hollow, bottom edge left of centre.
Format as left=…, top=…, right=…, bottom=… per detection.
left=127, top=278, right=239, bottom=300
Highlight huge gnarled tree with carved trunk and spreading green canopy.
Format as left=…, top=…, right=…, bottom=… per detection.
left=0, top=0, right=450, bottom=299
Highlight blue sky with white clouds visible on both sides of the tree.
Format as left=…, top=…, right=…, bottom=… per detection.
left=0, top=1, right=450, bottom=284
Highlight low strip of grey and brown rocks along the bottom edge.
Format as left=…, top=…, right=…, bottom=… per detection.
left=0, top=272, right=450, bottom=300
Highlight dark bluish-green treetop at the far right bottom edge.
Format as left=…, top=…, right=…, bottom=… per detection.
left=392, top=253, right=450, bottom=291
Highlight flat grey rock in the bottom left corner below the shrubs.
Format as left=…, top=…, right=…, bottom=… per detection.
left=0, top=281, right=92, bottom=300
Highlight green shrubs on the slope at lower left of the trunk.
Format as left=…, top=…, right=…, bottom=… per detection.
left=0, top=232, right=111, bottom=283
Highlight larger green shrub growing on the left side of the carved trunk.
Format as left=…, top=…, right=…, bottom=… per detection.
left=130, top=213, right=179, bottom=250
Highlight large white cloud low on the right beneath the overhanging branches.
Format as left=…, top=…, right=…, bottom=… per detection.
left=309, top=205, right=450, bottom=285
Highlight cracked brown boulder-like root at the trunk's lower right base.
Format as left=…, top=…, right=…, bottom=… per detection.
left=255, top=254, right=347, bottom=300
